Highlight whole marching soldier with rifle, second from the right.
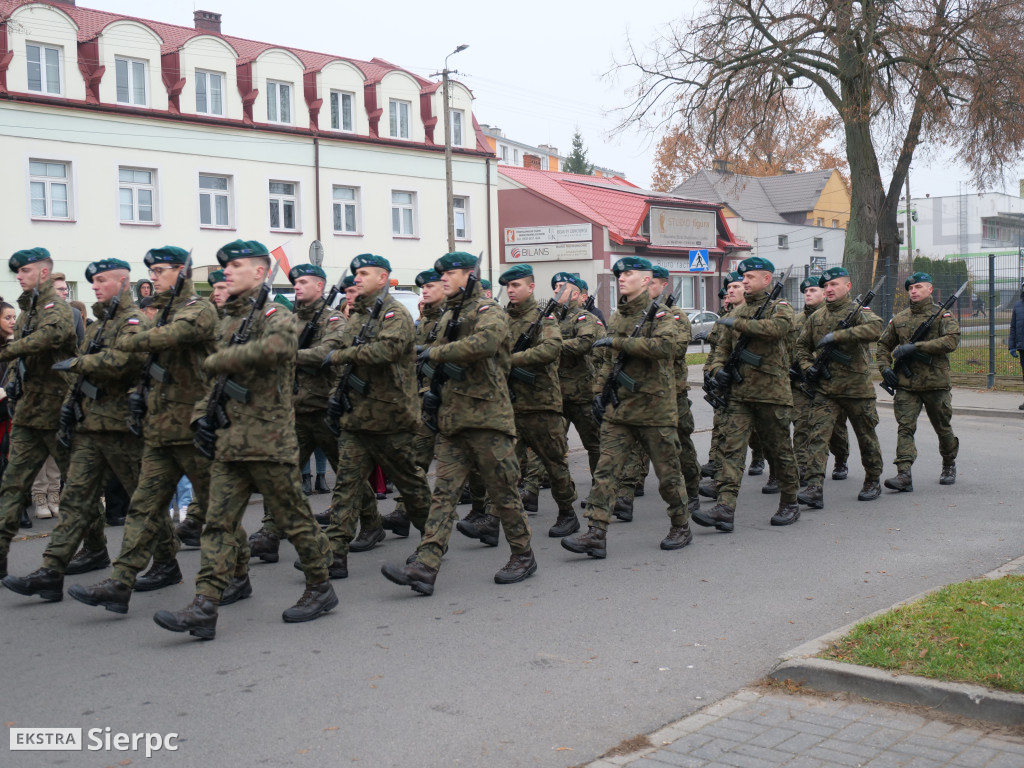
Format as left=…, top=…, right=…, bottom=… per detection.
left=797, top=266, right=882, bottom=509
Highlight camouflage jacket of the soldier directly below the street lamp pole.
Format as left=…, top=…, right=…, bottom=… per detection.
left=430, top=285, right=516, bottom=437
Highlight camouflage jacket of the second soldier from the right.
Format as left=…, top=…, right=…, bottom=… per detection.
left=797, top=295, right=882, bottom=399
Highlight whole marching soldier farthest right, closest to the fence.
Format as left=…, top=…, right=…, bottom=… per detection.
left=876, top=272, right=959, bottom=493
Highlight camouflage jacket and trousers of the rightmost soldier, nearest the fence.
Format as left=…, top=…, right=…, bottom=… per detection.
left=876, top=296, right=961, bottom=472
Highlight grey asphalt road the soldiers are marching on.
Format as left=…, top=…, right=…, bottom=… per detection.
left=0, top=401, right=1024, bottom=768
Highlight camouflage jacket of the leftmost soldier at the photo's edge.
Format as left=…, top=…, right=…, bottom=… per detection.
left=0, top=280, right=78, bottom=429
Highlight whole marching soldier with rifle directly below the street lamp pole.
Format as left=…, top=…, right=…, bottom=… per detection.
left=381, top=251, right=537, bottom=595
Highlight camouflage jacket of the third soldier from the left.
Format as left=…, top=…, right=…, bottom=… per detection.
left=118, top=280, right=219, bottom=445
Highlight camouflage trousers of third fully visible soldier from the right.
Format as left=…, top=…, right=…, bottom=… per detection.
left=715, top=398, right=800, bottom=509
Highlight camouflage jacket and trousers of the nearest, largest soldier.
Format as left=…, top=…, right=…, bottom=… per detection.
left=194, top=288, right=330, bottom=602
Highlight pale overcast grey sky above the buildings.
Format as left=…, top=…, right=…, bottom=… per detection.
left=86, top=0, right=1024, bottom=197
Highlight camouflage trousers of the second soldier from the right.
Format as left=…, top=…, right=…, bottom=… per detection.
left=806, top=392, right=882, bottom=485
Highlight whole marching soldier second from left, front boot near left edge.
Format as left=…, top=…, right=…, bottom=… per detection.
left=3, top=258, right=148, bottom=601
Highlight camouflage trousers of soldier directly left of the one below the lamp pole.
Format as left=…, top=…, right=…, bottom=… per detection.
left=327, top=430, right=430, bottom=555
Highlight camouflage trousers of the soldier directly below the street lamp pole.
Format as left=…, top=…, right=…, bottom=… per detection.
left=416, top=429, right=532, bottom=568
